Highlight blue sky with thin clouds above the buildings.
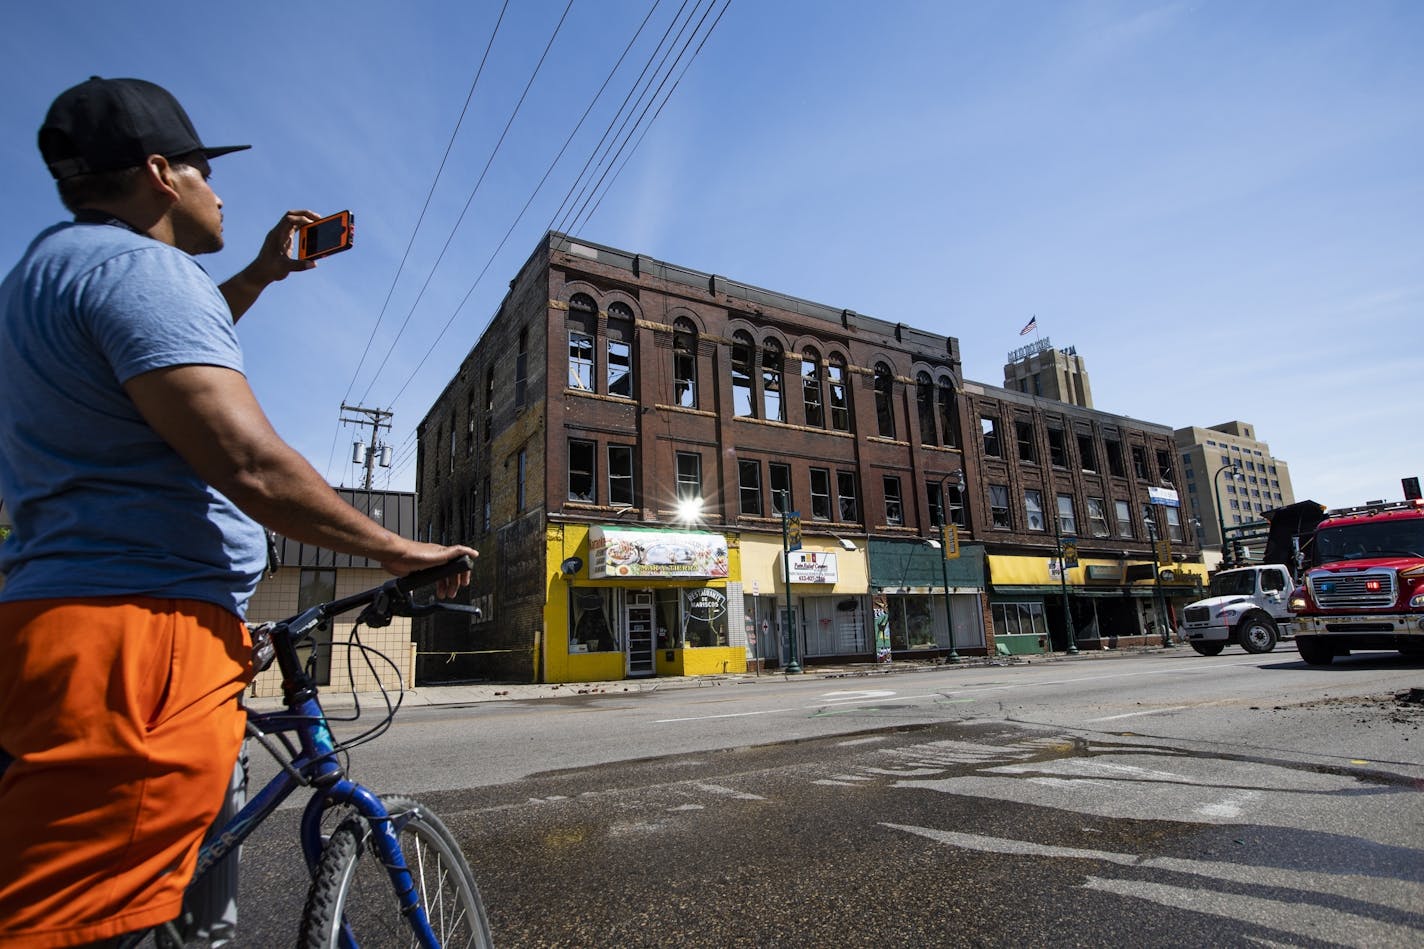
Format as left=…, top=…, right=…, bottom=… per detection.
left=0, top=0, right=1424, bottom=506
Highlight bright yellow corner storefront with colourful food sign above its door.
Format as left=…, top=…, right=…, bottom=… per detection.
left=540, top=524, right=746, bottom=683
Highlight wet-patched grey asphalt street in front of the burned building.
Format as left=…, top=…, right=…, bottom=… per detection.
left=227, top=650, right=1424, bottom=946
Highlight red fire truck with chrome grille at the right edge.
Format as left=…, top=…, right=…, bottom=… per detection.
left=1290, top=500, right=1424, bottom=665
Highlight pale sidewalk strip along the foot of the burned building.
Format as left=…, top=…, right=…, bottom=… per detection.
left=244, top=645, right=1189, bottom=711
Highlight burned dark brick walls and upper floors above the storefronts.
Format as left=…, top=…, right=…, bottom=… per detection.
left=417, top=234, right=1198, bottom=680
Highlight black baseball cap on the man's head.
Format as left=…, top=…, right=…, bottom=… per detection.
left=40, top=76, right=252, bottom=180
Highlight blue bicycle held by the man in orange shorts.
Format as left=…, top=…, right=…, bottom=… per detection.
left=120, top=557, right=493, bottom=949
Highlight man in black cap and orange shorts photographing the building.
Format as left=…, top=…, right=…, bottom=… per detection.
left=0, top=77, right=474, bottom=946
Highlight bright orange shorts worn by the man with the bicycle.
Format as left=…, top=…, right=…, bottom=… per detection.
left=0, top=597, right=252, bottom=948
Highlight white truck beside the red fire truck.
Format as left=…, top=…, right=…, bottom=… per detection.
left=1178, top=563, right=1294, bottom=655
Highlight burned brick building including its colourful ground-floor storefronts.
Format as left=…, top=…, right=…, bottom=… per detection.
left=416, top=232, right=1200, bottom=681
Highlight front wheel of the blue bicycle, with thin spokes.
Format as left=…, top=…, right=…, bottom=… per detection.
left=298, top=797, right=494, bottom=949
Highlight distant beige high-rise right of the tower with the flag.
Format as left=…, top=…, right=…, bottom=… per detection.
left=1175, top=422, right=1296, bottom=549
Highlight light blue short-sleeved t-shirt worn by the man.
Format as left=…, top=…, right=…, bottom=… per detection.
left=0, top=224, right=266, bottom=616
